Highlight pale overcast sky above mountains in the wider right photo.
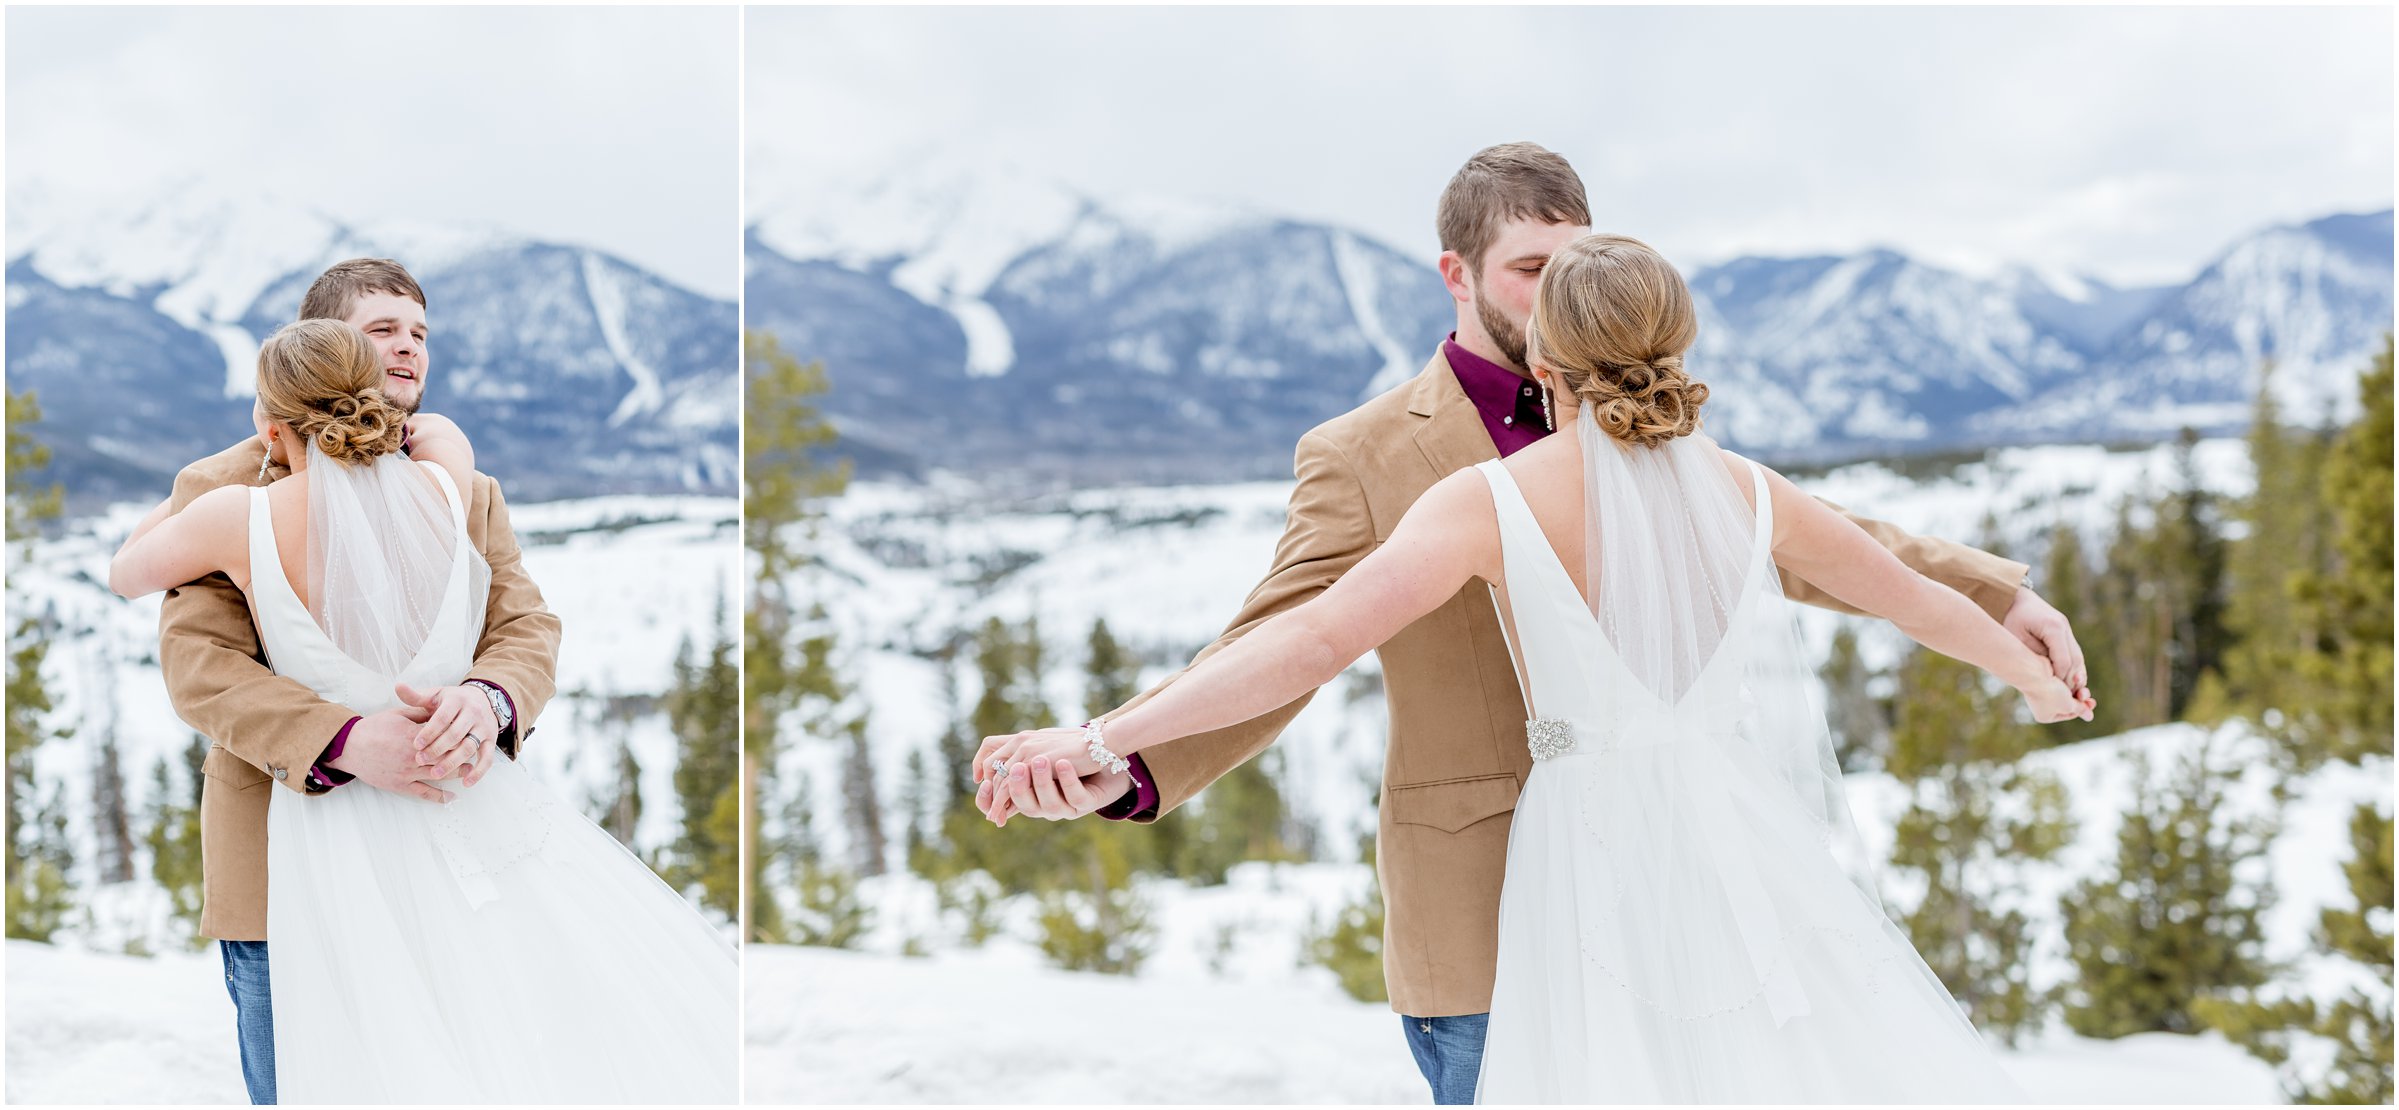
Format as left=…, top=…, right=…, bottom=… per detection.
left=746, top=7, right=2392, bottom=283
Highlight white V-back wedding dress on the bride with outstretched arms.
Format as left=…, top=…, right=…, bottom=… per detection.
left=1475, top=415, right=2025, bottom=1103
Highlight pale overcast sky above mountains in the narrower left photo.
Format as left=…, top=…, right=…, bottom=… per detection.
left=7, top=7, right=741, bottom=297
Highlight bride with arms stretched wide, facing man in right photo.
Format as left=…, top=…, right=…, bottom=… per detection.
left=974, top=235, right=2097, bottom=1103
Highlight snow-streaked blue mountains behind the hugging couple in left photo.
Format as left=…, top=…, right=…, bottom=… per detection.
left=7, top=182, right=741, bottom=508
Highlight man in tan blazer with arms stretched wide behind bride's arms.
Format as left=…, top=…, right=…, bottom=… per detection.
left=979, top=144, right=2085, bottom=1103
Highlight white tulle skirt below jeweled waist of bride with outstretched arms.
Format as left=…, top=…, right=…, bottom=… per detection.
left=1475, top=736, right=2025, bottom=1103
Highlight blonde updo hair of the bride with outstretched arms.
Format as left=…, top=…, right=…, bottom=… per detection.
left=1523, top=235, right=1708, bottom=446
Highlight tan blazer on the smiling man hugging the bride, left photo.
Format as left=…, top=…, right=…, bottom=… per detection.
left=158, top=436, right=559, bottom=940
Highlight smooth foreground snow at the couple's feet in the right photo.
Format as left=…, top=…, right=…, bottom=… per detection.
left=744, top=945, right=2281, bottom=1105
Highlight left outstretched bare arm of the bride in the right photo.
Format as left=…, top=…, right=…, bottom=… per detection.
left=974, top=470, right=1499, bottom=774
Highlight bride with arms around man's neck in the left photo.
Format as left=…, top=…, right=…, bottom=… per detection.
left=108, top=319, right=739, bottom=1103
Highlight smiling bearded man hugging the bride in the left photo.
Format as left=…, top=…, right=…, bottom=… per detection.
left=158, top=259, right=559, bottom=1105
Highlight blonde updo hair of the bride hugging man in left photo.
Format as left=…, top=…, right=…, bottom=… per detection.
left=259, top=319, right=408, bottom=465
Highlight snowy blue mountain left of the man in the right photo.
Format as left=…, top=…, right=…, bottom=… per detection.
left=746, top=177, right=1447, bottom=482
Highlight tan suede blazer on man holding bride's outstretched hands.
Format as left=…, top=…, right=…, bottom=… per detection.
left=1108, top=355, right=2027, bottom=1017
